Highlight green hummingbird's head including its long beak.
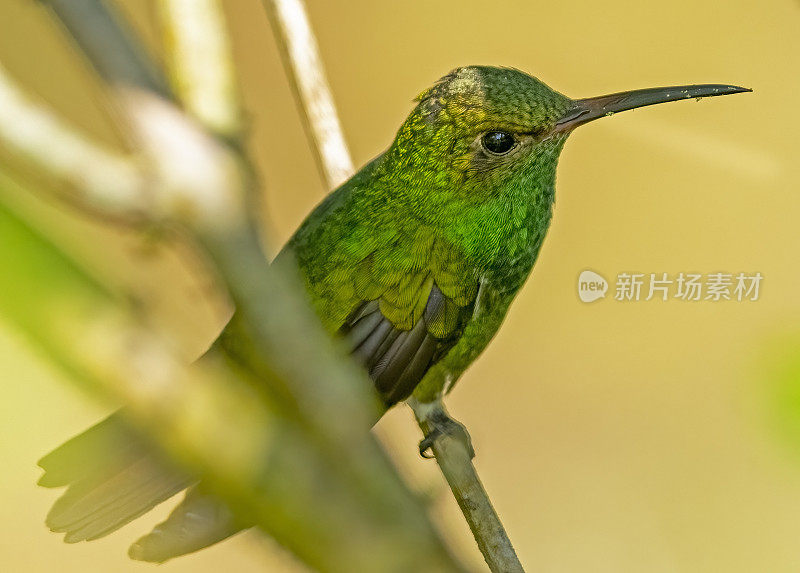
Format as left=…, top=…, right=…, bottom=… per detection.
left=387, top=66, right=750, bottom=201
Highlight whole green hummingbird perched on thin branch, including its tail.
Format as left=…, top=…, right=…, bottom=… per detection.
left=39, top=66, right=751, bottom=561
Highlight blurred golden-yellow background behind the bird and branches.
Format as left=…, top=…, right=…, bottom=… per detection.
left=0, top=0, right=800, bottom=573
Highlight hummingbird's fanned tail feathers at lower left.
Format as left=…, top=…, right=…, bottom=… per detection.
left=39, top=412, right=225, bottom=561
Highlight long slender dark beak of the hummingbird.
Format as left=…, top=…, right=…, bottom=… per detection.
left=553, top=84, right=753, bottom=132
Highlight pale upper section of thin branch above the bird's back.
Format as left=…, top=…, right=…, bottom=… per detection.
left=264, top=0, right=353, bottom=189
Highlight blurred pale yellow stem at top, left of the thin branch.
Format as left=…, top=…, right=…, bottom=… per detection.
left=159, top=0, right=241, bottom=138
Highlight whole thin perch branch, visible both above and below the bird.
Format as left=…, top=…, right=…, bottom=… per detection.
left=264, top=0, right=523, bottom=573
